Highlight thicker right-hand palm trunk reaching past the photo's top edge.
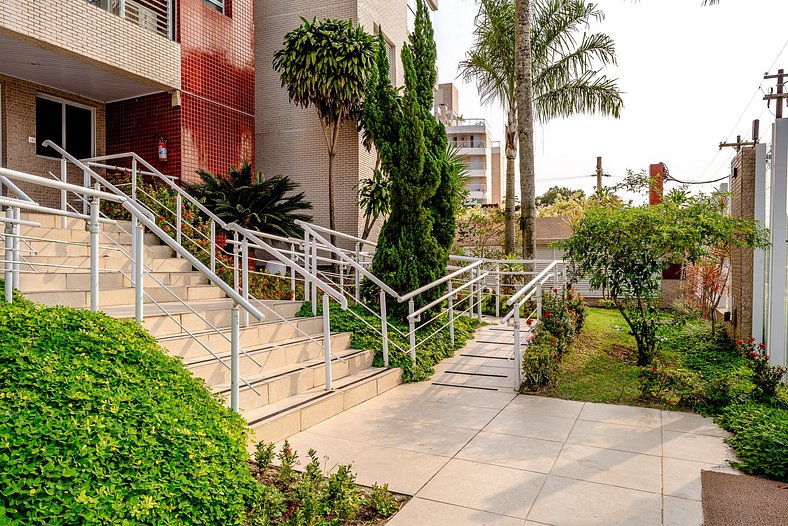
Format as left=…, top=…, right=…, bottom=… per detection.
left=515, top=0, right=536, bottom=259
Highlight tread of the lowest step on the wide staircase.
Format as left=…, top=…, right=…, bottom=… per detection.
left=242, top=367, right=401, bottom=426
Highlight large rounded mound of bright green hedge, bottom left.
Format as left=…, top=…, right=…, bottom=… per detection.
left=0, top=300, right=259, bottom=526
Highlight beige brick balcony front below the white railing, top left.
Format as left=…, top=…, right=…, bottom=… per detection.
left=0, top=0, right=181, bottom=89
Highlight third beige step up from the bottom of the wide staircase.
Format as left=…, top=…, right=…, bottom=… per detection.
left=186, top=333, right=350, bottom=386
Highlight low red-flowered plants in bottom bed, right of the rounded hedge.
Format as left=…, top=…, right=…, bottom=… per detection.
left=248, top=440, right=407, bottom=526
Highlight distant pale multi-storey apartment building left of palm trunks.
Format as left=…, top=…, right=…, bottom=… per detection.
left=435, top=83, right=501, bottom=205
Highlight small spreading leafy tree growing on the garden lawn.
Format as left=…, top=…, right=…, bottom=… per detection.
left=558, top=190, right=767, bottom=365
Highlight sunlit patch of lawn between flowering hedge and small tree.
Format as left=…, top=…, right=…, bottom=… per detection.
left=541, top=308, right=643, bottom=405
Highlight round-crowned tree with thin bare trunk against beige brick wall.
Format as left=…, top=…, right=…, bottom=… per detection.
left=274, top=18, right=375, bottom=243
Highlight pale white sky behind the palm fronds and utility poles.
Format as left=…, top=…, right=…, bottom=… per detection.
left=435, top=0, right=788, bottom=201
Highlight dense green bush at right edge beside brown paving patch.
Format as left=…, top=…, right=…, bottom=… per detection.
left=717, top=403, right=788, bottom=482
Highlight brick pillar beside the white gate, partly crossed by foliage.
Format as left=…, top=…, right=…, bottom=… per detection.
left=730, top=148, right=755, bottom=339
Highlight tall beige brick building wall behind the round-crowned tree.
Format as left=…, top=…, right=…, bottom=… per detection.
left=255, top=0, right=438, bottom=240
